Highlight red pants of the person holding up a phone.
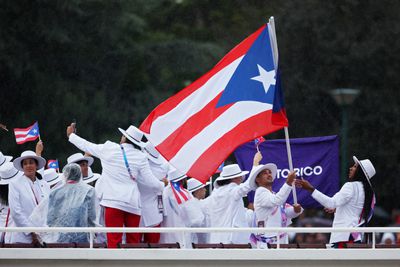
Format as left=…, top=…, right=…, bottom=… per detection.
left=104, top=207, right=141, bottom=248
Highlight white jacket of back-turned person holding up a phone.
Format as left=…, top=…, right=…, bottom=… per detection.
left=69, top=134, right=160, bottom=215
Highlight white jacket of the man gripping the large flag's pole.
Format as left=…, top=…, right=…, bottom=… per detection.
left=254, top=183, right=301, bottom=244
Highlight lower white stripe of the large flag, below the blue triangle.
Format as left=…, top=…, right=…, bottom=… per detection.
left=170, top=101, right=272, bottom=173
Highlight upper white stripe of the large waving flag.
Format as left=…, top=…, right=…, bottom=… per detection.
left=148, top=56, right=244, bottom=146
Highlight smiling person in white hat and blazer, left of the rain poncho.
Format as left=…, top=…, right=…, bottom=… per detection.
left=8, top=150, right=50, bottom=246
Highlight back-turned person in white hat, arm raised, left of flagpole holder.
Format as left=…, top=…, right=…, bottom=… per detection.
left=209, top=157, right=261, bottom=247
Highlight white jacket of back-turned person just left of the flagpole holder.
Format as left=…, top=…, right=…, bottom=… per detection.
left=209, top=180, right=252, bottom=244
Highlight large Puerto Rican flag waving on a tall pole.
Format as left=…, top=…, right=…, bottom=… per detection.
left=140, top=21, right=288, bottom=182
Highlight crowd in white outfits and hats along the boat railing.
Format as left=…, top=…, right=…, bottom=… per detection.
left=0, top=124, right=382, bottom=248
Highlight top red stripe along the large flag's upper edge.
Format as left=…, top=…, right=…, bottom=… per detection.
left=140, top=25, right=266, bottom=133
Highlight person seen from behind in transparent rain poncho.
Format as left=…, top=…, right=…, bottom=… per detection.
left=47, top=163, right=96, bottom=243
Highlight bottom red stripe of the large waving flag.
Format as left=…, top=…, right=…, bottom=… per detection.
left=187, top=110, right=287, bottom=183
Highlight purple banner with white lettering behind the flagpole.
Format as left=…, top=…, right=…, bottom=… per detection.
left=235, top=135, right=339, bottom=208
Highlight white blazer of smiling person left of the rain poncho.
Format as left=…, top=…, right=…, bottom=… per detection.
left=8, top=175, right=50, bottom=243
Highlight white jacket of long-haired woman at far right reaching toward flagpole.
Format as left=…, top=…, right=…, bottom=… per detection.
left=311, top=182, right=365, bottom=243
